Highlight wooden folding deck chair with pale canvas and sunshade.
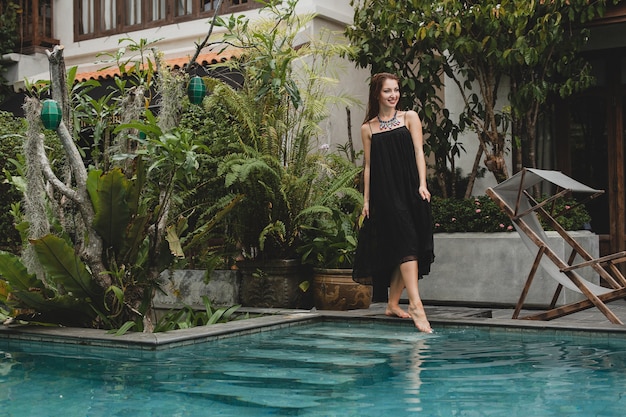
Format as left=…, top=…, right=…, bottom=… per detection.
left=486, top=168, right=626, bottom=324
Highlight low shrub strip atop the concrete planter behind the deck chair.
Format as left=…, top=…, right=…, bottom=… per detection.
left=431, top=196, right=591, bottom=233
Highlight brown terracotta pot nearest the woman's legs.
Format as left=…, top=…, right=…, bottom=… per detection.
left=312, top=268, right=372, bottom=310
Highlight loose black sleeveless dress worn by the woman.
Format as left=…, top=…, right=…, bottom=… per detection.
left=352, top=126, right=434, bottom=301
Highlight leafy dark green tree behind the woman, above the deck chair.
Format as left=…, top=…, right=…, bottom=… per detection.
left=346, top=0, right=608, bottom=191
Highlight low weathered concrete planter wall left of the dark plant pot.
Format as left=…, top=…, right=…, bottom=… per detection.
left=154, top=269, right=241, bottom=308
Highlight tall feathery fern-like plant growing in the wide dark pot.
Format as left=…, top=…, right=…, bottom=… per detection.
left=204, top=0, right=356, bottom=307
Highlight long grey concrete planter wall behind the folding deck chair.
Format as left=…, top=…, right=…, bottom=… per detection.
left=419, top=231, right=599, bottom=307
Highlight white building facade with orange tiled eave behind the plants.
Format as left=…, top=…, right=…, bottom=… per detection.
left=2, top=0, right=369, bottom=150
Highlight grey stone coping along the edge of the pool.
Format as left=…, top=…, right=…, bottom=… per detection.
left=0, top=303, right=626, bottom=350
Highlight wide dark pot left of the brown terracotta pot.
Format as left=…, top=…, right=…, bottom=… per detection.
left=237, top=259, right=312, bottom=308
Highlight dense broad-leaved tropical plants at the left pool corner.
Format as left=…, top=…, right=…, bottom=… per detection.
left=0, top=41, right=240, bottom=333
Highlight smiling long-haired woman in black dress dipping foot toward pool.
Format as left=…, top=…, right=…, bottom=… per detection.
left=353, top=73, right=434, bottom=333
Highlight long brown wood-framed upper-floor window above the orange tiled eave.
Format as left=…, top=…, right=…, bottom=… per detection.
left=74, top=0, right=261, bottom=41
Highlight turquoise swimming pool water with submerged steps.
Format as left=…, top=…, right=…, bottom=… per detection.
left=0, top=323, right=626, bottom=417
